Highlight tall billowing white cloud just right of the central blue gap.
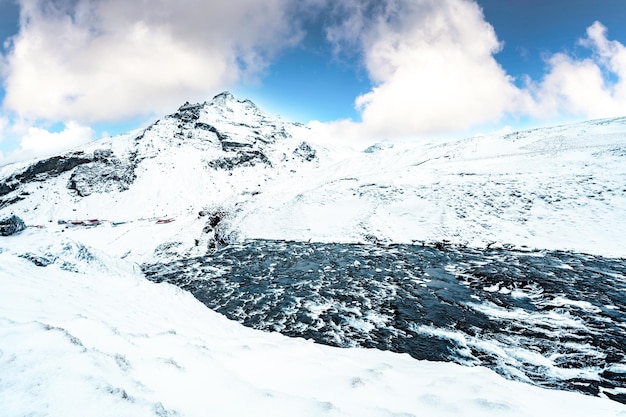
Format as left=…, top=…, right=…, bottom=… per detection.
left=328, top=0, right=528, bottom=140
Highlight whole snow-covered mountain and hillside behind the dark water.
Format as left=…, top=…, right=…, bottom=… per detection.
left=0, top=93, right=626, bottom=261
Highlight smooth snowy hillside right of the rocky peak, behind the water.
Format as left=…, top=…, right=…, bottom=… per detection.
left=235, top=115, right=626, bottom=256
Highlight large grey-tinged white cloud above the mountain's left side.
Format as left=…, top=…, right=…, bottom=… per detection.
left=4, top=0, right=300, bottom=123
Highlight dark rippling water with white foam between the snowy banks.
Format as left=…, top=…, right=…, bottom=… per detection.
left=144, top=241, right=626, bottom=403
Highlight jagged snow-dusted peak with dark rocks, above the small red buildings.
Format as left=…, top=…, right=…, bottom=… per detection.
left=0, top=91, right=318, bottom=223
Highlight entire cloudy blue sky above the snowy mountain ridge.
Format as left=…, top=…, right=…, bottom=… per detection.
left=0, top=0, right=626, bottom=165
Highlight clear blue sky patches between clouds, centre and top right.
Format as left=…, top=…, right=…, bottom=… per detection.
left=238, top=0, right=626, bottom=122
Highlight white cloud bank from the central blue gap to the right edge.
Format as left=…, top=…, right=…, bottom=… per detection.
left=324, top=0, right=626, bottom=138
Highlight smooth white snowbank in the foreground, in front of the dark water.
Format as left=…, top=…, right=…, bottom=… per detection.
left=0, top=230, right=626, bottom=417
